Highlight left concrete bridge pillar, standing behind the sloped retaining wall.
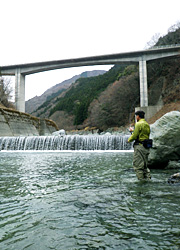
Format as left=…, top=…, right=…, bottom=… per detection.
left=15, top=69, right=25, bottom=112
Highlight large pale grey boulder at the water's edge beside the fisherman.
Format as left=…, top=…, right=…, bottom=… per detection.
left=148, top=111, right=180, bottom=168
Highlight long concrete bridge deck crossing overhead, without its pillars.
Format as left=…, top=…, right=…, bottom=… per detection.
left=0, top=44, right=180, bottom=75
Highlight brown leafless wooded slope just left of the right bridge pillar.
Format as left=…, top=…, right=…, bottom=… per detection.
left=87, top=72, right=139, bottom=130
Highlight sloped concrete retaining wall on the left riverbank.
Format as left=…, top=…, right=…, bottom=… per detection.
left=0, top=108, right=58, bottom=136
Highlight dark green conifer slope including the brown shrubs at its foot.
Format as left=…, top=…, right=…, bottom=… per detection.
left=33, top=65, right=126, bottom=129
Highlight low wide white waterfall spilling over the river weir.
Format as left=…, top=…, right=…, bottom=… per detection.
left=0, top=135, right=132, bottom=150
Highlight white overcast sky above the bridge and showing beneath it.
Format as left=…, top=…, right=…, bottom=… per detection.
left=0, top=0, right=180, bottom=100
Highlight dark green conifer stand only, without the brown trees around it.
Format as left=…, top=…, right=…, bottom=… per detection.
left=49, top=66, right=128, bottom=125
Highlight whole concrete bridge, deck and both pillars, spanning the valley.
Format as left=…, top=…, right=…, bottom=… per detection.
left=0, top=44, right=180, bottom=112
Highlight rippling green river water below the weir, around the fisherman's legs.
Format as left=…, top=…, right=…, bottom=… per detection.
left=0, top=151, right=180, bottom=250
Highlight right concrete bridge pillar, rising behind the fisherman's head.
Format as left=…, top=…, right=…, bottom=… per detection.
left=139, top=59, right=148, bottom=107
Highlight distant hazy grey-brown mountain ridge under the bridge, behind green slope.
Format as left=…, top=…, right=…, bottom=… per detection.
left=25, top=70, right=106, bottom=115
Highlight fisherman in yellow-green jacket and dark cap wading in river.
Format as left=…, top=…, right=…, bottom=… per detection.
left=128, top=111, right=152, bottom=180
